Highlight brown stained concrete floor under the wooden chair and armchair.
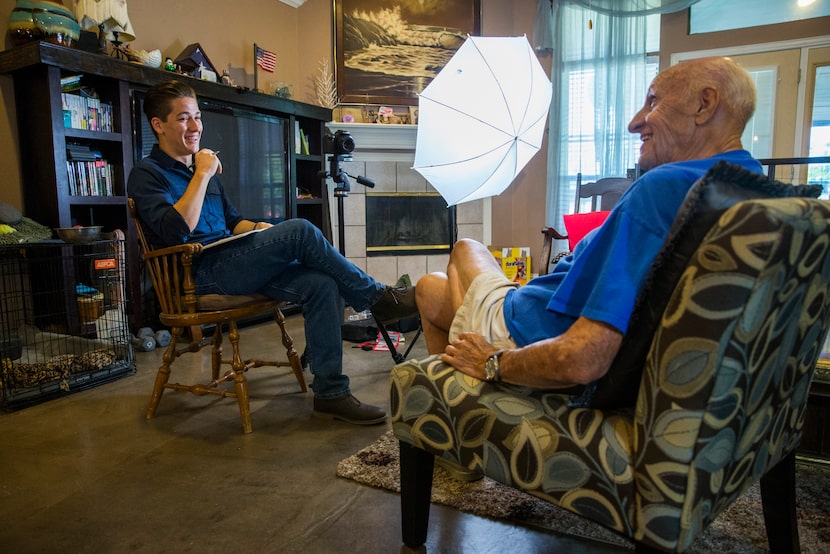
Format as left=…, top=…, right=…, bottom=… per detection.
left=0, top=316, right=620, bottom=553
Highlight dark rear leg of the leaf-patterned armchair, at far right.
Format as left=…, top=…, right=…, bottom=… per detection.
left=761, top=451, right=801, bottom=554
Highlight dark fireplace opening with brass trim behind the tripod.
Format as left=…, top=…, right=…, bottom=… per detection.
left=366, top=192, right=456, bottom=256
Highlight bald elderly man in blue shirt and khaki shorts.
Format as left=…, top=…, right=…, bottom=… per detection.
left=416, top=58, right=761, bottom=389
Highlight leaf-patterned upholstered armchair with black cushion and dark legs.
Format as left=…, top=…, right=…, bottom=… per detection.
left=391, top=162, right=830, bottom=552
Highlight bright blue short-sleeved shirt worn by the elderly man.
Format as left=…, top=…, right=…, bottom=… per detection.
left=504, top=150, right=762, bottom=346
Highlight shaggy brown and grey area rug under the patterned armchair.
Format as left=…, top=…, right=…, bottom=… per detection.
left=337, top=431, right=830, bottom=554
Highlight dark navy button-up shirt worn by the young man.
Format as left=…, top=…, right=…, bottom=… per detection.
left=127, top=144, right=243, bottom=248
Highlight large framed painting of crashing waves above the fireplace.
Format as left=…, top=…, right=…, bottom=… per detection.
left=333, top=0, right=481, bottom=105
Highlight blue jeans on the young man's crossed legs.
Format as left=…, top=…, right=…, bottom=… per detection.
left=194, top=219, right=384, bottom=398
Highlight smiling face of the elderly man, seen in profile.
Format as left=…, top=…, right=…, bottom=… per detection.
left=628, top=73, right=698, bottom=171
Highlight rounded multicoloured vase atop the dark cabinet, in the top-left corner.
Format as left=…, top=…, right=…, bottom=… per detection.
left=8, top=0, right=81, bottom=47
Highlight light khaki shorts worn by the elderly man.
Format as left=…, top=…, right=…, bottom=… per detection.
left=450, top=272, right=519, bottom=348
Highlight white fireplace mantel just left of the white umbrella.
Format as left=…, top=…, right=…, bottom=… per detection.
left=326, top=121, right=418, bottom=162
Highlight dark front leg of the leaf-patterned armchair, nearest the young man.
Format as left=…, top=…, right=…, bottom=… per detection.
left=399, top=441, right=435, bottom=548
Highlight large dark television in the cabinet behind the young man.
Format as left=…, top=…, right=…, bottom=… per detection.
left=133, top=93, right=289, bottom=223
